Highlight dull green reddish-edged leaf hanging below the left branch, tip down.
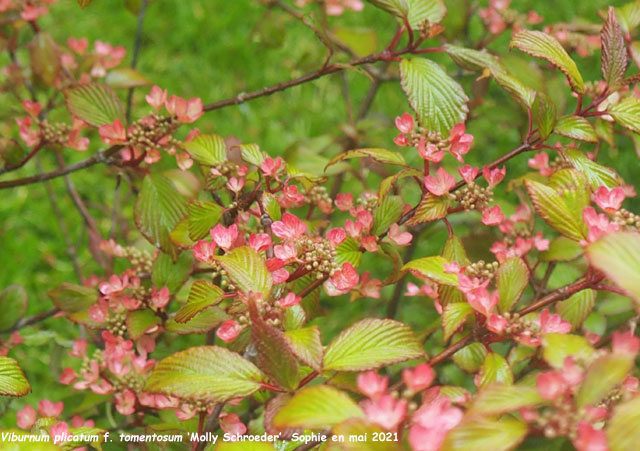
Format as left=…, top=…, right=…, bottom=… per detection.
left=134, top=174, right=187, bottom=260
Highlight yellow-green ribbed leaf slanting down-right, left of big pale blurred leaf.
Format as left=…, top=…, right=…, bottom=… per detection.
left=524, top=180, right=585, bottom=241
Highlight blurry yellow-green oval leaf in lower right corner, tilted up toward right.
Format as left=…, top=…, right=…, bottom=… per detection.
left=577, top=354, right=633, bottom=408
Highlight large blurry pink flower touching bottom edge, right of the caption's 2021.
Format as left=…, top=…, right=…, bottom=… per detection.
left=409, top=395, right=463, bottom=451
